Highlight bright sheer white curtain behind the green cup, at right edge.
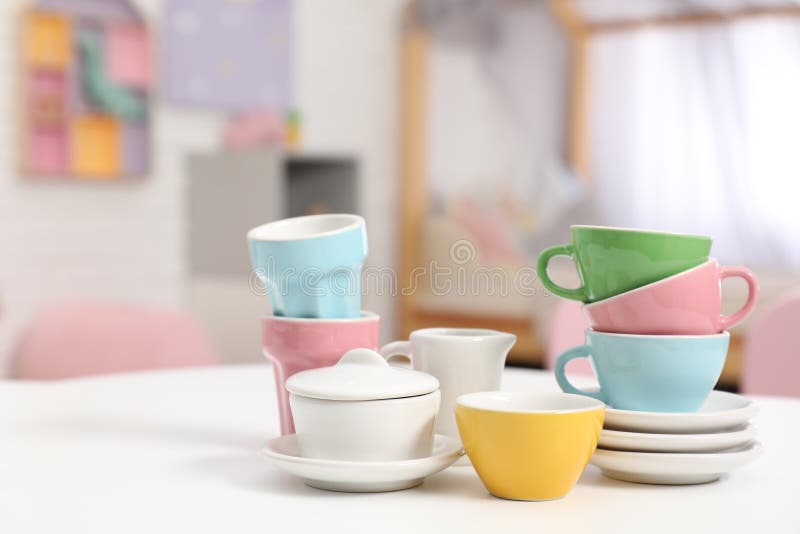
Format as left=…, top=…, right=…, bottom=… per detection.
left=590, top=18, right=800, bottom=268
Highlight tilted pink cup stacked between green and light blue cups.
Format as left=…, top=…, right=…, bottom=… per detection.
left=583, top=259, right=758, bottom=335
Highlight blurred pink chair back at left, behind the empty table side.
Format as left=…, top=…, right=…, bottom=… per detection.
left=10, top=301, right=219, bottom=380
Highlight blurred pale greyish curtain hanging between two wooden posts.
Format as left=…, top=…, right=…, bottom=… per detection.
left=423, top=0, right=569, bottom=203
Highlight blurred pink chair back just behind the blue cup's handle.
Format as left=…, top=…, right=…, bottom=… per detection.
left=546, top=300, right=594, bottom=375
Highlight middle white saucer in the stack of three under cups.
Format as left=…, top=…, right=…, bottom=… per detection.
left=598, top=425, right=756, bottom=452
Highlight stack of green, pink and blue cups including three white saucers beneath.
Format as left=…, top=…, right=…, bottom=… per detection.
left=538, top=226, right=761, bottom=484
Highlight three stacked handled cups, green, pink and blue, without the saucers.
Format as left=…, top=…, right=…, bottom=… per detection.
left=537, top=226, right=758, bottom=412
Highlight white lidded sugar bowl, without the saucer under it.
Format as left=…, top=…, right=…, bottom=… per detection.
left=286, top=349, right=441, bottom=462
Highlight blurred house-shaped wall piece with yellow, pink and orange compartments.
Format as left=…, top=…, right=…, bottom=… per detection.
left=21, top=0, right=152, bottom=179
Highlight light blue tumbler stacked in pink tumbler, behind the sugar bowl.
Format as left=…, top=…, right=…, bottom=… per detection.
left=247, top=214, right=379, bottom=435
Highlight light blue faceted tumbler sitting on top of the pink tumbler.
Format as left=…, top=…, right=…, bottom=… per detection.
left=247, top=214, right=367, bottom=319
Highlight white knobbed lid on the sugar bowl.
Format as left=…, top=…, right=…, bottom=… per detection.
left=286, top=349, right=439, bottom=401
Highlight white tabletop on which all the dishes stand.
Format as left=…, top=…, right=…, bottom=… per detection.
left=0, top=365, right=800, bottom=534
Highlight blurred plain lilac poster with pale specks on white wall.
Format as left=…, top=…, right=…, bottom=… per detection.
left=163, top=0, right=292, bottom=113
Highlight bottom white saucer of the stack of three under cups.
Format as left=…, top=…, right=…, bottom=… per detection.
left=591, top=442, right=762, bottom=484
